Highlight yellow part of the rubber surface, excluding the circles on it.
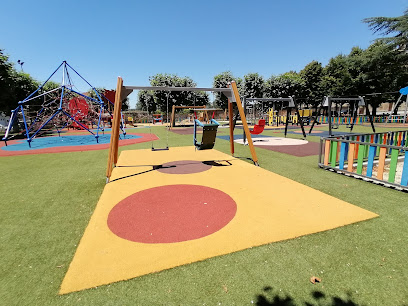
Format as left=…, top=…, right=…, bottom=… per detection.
left=60, top=147, right=377, bottom=294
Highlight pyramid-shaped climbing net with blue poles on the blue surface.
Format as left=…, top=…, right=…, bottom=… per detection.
left=3, top=61, right=126, bottom=147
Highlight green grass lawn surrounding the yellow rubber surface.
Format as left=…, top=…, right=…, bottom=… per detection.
left=0, top=126, right=408, bottom=305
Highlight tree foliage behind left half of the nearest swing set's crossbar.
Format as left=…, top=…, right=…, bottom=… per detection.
left=138, top=73, right=209, bottom=113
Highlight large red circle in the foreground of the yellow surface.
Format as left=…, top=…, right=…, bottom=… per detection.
left=108, top=185, right=237, bottom=243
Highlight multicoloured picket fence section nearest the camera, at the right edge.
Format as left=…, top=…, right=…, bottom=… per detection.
left=319, top=130, right=408, bottom=190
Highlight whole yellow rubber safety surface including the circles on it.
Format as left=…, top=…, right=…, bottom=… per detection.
left=60, top=147, right=377, bottom=294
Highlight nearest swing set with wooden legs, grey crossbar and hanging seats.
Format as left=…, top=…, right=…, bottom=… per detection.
left=106, top=77, right=259, bottom=183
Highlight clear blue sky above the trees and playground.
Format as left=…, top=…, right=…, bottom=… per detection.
left=0, top=0, right=408, bottom=104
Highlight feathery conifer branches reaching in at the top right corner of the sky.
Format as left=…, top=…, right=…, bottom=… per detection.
left=363, top=9, right=408, bottom=51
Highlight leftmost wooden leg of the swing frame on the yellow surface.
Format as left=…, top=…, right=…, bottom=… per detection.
left=106, top=77, right=123, bottom=183
